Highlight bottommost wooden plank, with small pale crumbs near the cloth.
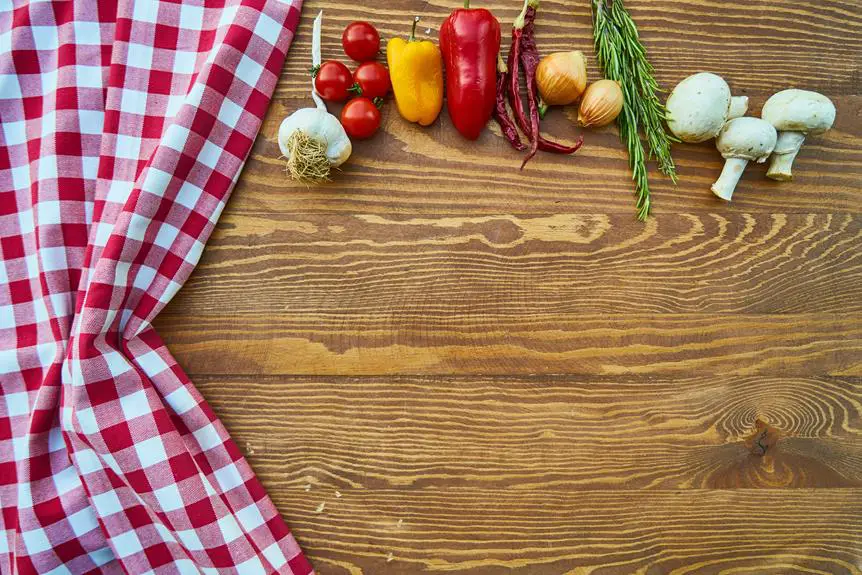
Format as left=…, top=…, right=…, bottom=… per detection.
left=275, top=489, right=862, bottom=575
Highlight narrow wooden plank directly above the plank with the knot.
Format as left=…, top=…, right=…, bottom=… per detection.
left=159, top=312, right=862, bottom=376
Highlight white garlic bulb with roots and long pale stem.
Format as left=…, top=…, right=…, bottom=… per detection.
left=278, top=10, right=353, bottom=183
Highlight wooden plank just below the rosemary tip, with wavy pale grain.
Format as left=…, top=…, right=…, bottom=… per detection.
left=167, top=213, right=862, bottom=318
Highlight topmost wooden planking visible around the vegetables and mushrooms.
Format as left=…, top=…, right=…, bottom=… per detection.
left=224, top=0, right=862, bottom=215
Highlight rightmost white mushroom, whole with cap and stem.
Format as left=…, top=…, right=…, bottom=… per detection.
left=760, top=89, right=835, bottom=181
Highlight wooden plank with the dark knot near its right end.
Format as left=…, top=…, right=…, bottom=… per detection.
left=196, top=376, right=862, bottom=492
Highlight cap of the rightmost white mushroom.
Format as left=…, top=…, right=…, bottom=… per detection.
left=760, top=88, right=835, bottom=134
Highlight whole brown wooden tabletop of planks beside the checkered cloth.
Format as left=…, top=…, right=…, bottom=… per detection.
left=159, top=0, right=862, bottom=575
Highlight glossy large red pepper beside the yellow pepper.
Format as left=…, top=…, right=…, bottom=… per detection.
left=440, top=0, right=500, bottom=140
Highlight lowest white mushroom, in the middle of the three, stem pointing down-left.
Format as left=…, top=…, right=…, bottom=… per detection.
left=712, top=117, right=778, bottom=202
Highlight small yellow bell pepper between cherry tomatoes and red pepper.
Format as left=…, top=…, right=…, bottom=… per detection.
left=386, top=17, right=443, bottom=126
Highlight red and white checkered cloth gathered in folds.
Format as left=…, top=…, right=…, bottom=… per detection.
left=0, top=0, right=311, bottom=575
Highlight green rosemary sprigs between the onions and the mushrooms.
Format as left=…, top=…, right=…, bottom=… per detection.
left=590, top=0, right=677, bottom=220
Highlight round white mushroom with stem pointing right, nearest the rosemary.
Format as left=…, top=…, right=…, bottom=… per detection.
left=667, top=72, right=748, bottom=144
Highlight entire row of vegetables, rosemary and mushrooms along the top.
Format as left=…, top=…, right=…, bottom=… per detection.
left=278, top=0, right=835, bottom=220
